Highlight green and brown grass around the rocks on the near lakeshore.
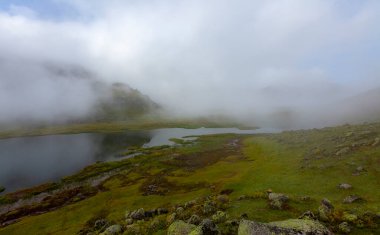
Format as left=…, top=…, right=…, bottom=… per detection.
left=0, top=124, right=380, bottom=234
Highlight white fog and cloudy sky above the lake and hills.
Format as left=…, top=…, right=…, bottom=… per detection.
left=0, top=0, right=380, bottom=128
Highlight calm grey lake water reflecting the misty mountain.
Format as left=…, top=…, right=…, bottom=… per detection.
left=0, top=128, right=277, bottom=192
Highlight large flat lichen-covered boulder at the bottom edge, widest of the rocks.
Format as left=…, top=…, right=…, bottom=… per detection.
left=238, top=219, right=332, bottom=235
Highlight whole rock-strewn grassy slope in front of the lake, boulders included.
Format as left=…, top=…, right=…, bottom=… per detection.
left=0, top=123, right=380, bottom=234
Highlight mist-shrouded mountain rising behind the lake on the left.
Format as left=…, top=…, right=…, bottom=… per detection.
left=0, top=61, right=160, bottom=126
